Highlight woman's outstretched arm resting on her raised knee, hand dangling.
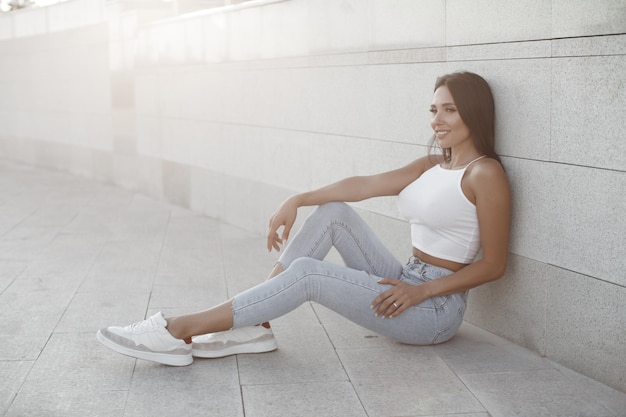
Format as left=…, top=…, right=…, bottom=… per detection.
left=267, top=156, right=439, bottom=251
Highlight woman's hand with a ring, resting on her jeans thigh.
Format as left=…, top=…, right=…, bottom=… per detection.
left=370, top=278, right=428, bottom=319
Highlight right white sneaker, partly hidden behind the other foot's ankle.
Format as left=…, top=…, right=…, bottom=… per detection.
left=191, top=326, right=278, bottom=358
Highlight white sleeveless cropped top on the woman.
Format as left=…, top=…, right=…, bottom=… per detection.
left=398, top=156, right=484, bottom=264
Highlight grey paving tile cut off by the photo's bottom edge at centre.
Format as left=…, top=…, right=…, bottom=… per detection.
left=243, top=382, right=367, bottom=417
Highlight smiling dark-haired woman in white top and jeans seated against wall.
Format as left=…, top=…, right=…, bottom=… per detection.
left=97, top=72, right=510, bottom=366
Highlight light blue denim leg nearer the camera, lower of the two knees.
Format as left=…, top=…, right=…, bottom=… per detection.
left=232, top=258, right=444, bottom=344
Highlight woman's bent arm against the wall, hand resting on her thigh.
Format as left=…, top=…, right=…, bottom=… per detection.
left=373, top=160, right=511, bottom=317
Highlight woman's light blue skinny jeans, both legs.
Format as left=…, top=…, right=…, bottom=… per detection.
left=233, top=203, right=467, bottom=345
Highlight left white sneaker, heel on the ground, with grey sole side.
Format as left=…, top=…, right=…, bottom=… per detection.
left=96, top=312, right=193, bottom=366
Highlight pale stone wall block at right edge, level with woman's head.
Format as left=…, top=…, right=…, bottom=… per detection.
left=550, top=54, right=626, bottom=171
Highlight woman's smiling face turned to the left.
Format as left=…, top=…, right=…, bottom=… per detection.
left=430, top=85, right=472, bottom=149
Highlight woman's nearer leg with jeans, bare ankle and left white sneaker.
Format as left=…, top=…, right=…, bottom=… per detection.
left=98, top=258, right=458, bottom=366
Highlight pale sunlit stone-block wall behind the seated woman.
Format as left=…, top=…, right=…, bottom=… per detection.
left=0, top=0, right=626, bottom=390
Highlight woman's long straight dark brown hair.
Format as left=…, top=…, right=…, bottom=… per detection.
left=431, top=71, right=501, bottom=163
